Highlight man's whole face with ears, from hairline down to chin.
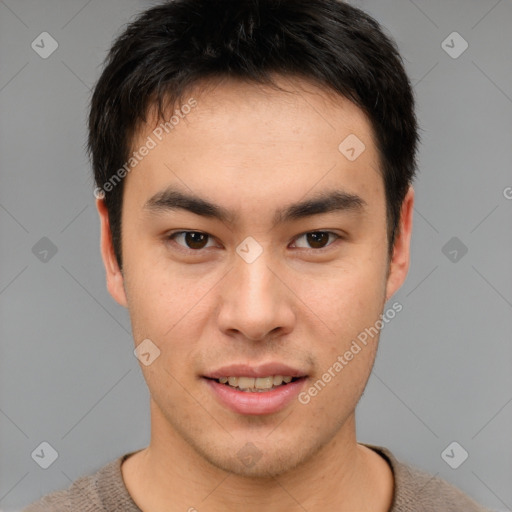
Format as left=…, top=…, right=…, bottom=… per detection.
left=98, top=74, right=413, bottom=476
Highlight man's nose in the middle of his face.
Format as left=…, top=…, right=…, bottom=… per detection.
left=217, top=247, right=296, bottom=341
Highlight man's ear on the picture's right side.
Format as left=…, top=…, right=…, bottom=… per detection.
left=386, top=186, right=414, bottom=301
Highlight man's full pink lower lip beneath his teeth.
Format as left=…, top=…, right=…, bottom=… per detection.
left=205, top=377, right=306, bottom=415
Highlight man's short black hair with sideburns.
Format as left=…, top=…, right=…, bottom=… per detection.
left=88, top=0, right=419, bottom=268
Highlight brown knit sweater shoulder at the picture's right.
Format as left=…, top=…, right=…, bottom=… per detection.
left=366, top=445, right=489, bottom=512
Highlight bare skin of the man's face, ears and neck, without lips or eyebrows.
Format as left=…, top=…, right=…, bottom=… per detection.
left=97, top=77, right=414, bottom=512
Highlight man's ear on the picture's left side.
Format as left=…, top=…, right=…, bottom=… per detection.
left=96, top=198, right=128, bottom=307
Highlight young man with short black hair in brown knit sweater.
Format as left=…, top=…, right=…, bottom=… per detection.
left=26, top=0, right=484, bottom=512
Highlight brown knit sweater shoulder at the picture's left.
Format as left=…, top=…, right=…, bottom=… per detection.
left=23, top=452, right=138, bottom=512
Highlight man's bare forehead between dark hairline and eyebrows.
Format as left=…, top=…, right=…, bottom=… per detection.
left=127, top=77, right=383, bottom=218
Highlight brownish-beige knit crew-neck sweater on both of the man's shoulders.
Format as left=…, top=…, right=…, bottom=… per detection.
left=23, top=445, right=489, bottom=512
